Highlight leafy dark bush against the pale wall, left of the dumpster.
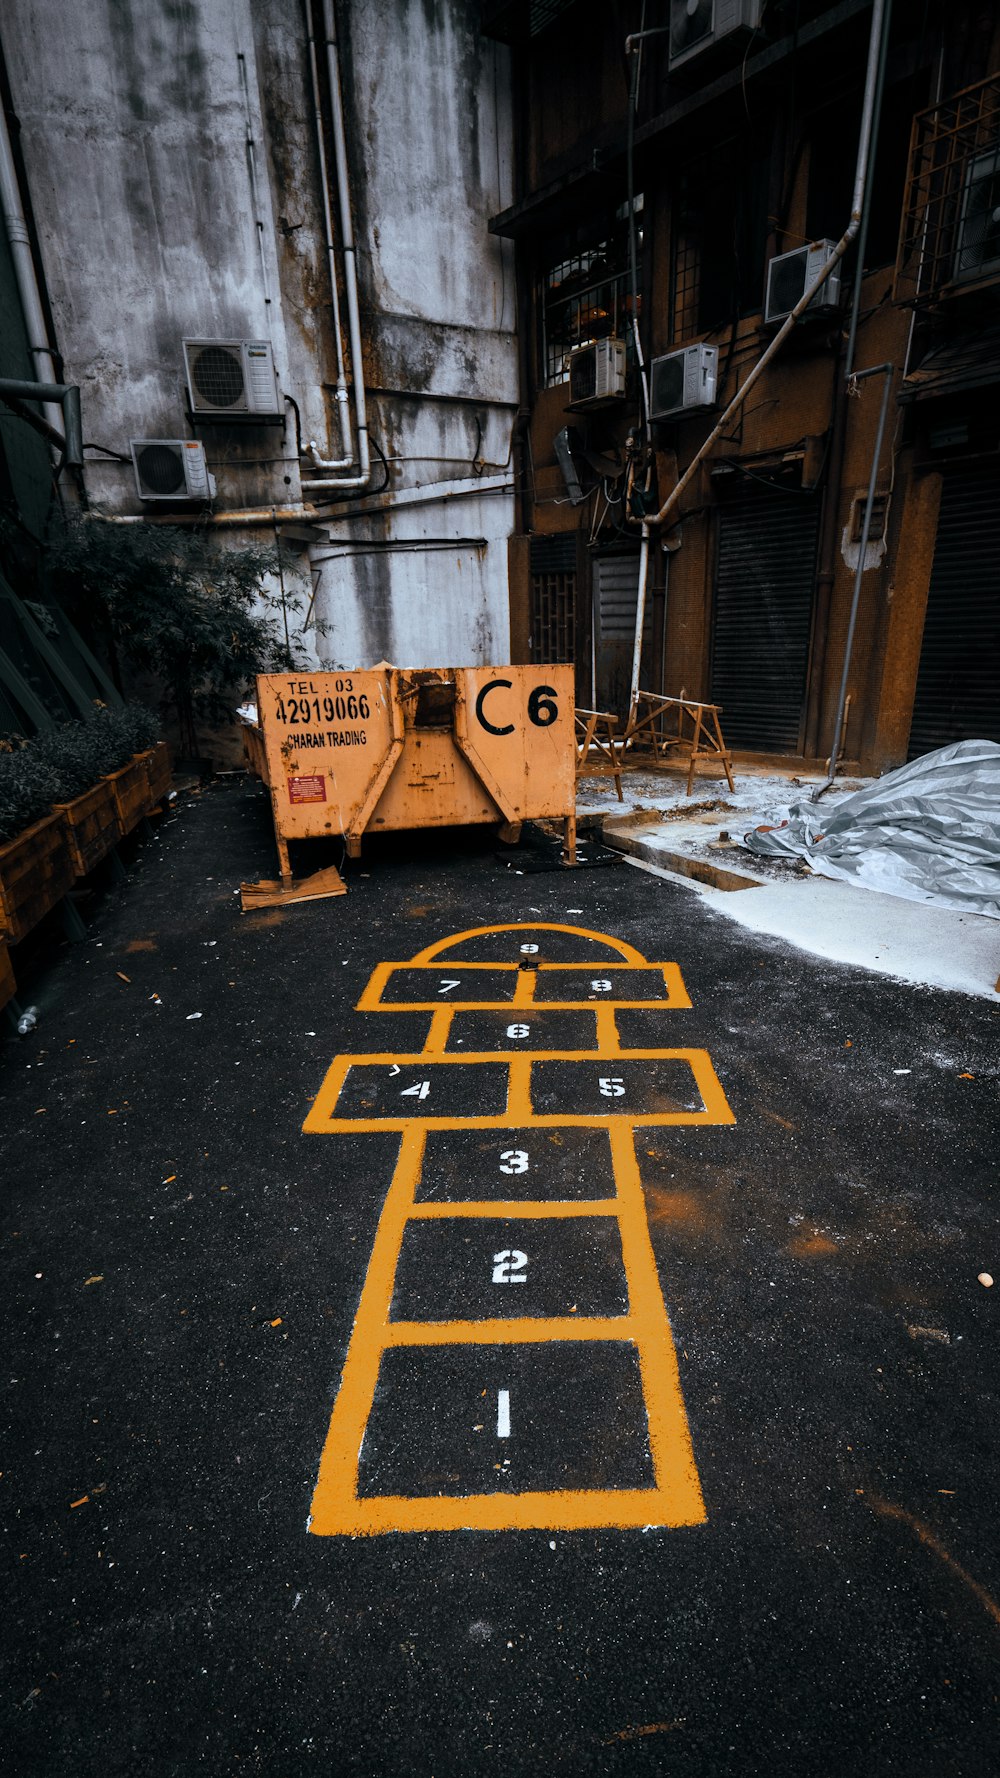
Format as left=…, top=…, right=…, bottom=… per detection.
left=48, top=517, right=297, bottom=754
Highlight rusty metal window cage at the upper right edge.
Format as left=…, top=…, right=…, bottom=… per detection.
left=893, top=75, right=1000, bottom=306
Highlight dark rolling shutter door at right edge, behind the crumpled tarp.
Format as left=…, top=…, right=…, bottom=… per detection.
left=909, top=466, right=1000, bottom=759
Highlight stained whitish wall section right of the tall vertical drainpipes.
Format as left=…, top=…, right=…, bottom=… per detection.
left=313, top=0, right=518, bottom=667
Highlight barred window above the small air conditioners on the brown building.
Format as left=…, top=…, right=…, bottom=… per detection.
left=537, top=196, right=642, bottom=389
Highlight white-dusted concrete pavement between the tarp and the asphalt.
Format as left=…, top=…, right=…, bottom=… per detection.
left=578, top=761, right=1000, bottom=1001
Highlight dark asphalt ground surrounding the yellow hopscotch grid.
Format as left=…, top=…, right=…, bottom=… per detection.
left=0, top=782, right=1000, bottom=1778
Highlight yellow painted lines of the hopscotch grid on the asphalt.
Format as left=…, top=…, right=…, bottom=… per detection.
left=302, top=925, right=735, bottom=1536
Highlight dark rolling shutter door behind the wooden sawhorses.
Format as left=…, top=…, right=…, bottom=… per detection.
left=712, top=484, right=820, bottom=752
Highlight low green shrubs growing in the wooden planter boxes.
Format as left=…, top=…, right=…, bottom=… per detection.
left=0, top=704, right=160, bottom=845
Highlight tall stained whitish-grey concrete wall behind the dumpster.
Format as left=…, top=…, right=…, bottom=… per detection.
left=0, top=0, right=518, bottom=667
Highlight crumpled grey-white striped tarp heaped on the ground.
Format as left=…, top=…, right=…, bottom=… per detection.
left=744, top=741, right=1000, bottom=919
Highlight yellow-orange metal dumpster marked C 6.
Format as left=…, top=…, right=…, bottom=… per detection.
left=236, top=667, right=577, bottom=907
